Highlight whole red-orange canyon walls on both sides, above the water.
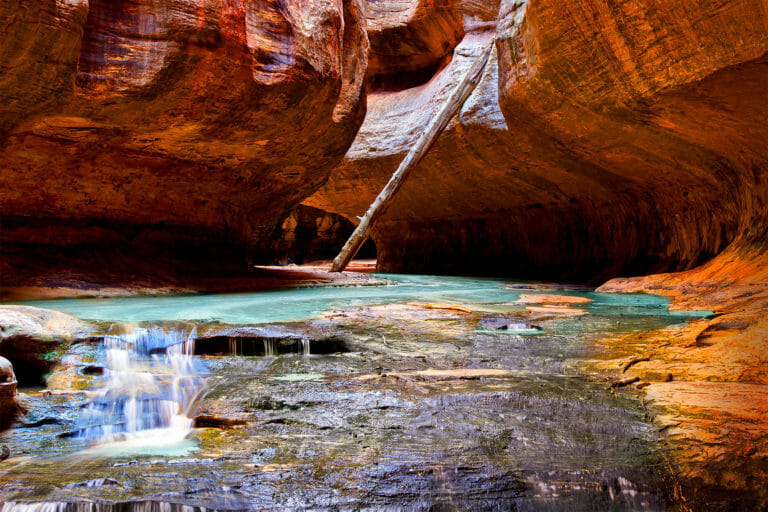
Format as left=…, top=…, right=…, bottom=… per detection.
left=0, top=0, right=768, bottom=285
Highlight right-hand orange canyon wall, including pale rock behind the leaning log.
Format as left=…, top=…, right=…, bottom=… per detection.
left=305, top=0, right=768, bottom=282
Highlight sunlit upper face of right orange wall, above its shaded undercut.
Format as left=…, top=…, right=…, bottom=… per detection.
left=499, top=0, right=768, bottom=111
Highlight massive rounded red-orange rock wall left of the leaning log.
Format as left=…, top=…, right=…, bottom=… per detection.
left=0, top=0, right=368, bottom=284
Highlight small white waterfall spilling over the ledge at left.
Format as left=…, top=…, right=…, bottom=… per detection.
left=77, top=327, right=205, bottom=444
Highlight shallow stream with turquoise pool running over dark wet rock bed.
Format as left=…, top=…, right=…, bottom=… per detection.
left=0, top=275, right=706, bottom=512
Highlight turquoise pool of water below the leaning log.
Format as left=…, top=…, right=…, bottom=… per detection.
left=18, top=274, right=712, bottom=324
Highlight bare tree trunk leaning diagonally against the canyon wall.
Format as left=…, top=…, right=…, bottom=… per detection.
left=331, top=38, right=496, bottom=272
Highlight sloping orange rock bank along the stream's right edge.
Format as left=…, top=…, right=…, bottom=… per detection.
left=587, top=243, right=768, bottom=510
